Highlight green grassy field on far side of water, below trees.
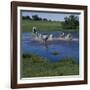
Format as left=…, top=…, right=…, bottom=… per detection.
left=21, top=20, right=76, bottom=32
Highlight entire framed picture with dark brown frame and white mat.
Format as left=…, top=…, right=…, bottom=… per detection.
left=11, top=1, right=87, bottom=88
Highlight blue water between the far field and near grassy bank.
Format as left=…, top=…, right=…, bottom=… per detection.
left=21, top=32, right=79, bottom=61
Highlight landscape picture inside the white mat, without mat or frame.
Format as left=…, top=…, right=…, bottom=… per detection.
left=21, top=11, right=79, bottom=78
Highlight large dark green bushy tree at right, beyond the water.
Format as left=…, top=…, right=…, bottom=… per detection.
left=62, top=15, right=79, bottom=29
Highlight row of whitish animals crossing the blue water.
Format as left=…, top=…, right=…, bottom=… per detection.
left=32, top=27, right=78, bottom=42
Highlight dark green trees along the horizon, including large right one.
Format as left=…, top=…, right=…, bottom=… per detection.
left=22, top=15, right=79, bottom=29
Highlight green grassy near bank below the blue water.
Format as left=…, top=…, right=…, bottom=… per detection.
left=21, top=54, right=79, bottom=77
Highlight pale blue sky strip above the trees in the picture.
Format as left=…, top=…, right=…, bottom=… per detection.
left=21, top=11, right=79, bottom=21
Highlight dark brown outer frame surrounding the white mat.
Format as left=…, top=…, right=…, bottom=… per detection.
left=11, top=1, right=88, bottom=89
